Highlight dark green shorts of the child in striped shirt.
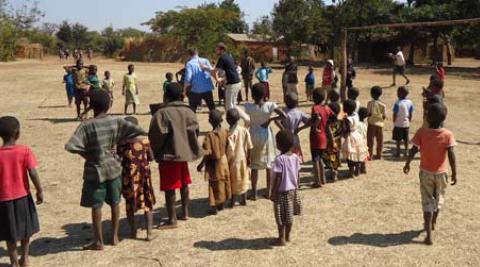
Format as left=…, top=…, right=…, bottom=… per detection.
left=80, top=177, right=122, bottom=209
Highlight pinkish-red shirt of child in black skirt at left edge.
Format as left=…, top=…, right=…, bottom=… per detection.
left=0, top=145, right=37, bottom=201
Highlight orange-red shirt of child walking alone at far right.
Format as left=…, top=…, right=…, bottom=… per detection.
left=412, top=128, right=456, bottom=173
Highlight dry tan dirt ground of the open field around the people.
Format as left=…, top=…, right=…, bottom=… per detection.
left=0, top=56, right=480, bottom=267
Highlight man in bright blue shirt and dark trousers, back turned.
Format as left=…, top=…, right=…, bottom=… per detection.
left=183, top=49, right=215, bottom=112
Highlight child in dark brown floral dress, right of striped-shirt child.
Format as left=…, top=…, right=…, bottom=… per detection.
left=118, top=117, right=155, bottom=241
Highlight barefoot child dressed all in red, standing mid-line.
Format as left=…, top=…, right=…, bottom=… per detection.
left=310, top=88, right=335, bottom=187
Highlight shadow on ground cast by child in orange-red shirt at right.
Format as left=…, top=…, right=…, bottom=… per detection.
left=328, top=230, right=423, bottom=248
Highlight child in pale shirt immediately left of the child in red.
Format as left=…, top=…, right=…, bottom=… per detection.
left=276, top=93, right=310, bottom=162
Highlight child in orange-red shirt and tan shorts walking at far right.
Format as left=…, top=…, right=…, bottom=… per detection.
left=403, top=103, right=457, bottom=245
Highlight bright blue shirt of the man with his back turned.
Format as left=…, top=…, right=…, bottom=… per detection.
left=184, top=56, right=213, bottom=94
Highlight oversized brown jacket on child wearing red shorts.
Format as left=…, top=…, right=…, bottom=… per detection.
left=148, top=101, right=202, bottom=162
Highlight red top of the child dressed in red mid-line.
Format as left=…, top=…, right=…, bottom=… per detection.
left=310, top=105, right=335, bottom=149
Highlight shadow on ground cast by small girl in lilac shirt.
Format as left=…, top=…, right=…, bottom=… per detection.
left=193, top=237, right=275, bottom=251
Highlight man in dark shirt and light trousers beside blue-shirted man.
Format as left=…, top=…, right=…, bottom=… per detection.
left=215, top=43, right=242, bottom=110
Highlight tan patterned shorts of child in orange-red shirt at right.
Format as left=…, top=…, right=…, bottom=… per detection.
left=420, top=170, right=448, bottom=212
